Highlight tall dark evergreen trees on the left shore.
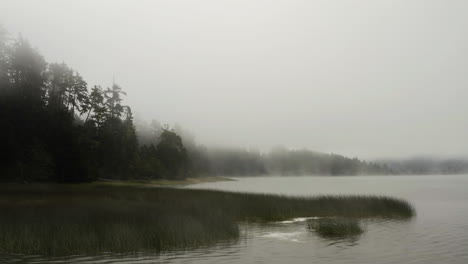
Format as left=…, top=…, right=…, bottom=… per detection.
left=0, top=33, right=189, bottom=182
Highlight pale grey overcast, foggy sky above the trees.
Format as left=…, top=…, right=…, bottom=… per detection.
left=0, top=0, right=468, bottom=158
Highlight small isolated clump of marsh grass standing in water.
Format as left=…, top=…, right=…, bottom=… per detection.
left=307, top=218, right=364, bottom=238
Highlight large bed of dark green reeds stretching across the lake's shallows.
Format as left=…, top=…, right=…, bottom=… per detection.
left=0, top=183, right=414, bottom=255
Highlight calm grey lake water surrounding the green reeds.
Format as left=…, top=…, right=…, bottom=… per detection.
left=3, top=175, right=468, bottom=264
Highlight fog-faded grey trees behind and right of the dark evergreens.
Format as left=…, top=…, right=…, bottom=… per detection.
left=137, top=120, right=393, bottom=176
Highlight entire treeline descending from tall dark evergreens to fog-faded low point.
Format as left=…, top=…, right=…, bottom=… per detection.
left=0, top=30, right=390, bottom=182
